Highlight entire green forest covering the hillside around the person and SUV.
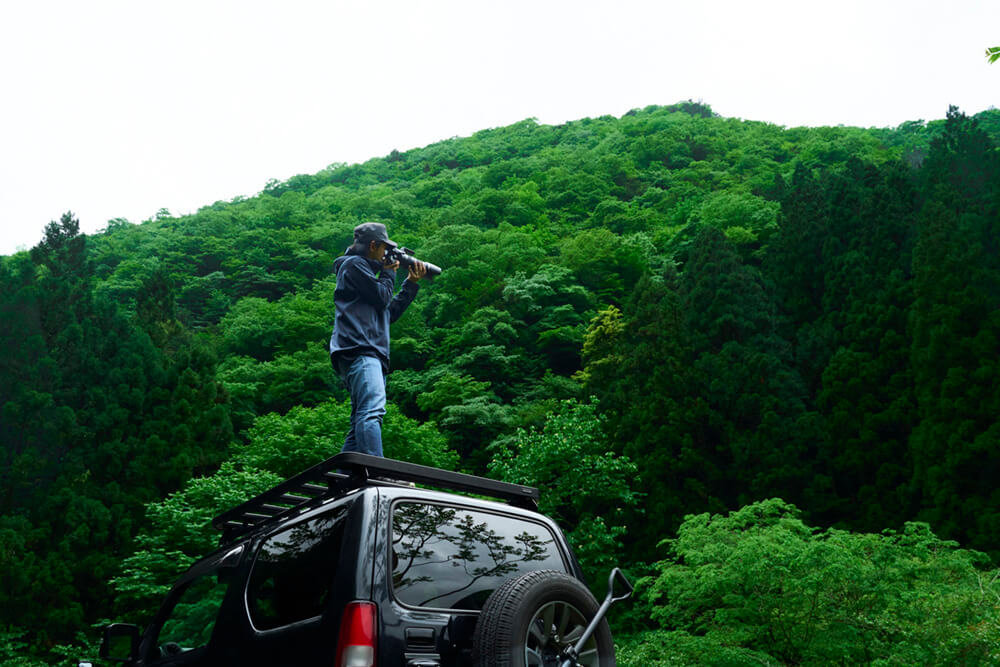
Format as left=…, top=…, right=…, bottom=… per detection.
left=0, top=101, right=1000, bottom=667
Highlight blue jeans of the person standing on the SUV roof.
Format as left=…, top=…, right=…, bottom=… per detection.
left=337, top=355, right=385, bottom=456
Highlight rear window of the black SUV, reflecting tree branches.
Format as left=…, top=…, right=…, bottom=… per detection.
left=392, top=502, right=566, bottom=610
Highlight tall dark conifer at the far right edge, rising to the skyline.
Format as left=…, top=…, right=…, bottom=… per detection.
left=910, top=108, right=1000, bottom=550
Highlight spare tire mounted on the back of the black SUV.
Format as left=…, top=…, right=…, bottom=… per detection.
left=472, top=570, right=615, bottom=667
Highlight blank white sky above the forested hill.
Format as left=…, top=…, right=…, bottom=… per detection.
left=0, top=0, right=1000, bottom=254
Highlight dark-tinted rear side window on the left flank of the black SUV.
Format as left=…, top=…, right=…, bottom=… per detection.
left=247, top=504, right=347, bottom=630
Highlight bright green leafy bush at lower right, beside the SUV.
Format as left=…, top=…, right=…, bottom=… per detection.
left=636, top=499, right=1000, bottom=665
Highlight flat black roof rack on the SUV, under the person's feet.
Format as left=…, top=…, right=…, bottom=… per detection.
left=212, top=452, right=539, bottom=543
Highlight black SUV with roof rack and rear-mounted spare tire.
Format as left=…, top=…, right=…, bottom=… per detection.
left=88, top=453, right=631, bottom=667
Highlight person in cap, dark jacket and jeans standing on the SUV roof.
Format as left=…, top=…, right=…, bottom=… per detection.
left=330, top=222, right=427, bottom=456
